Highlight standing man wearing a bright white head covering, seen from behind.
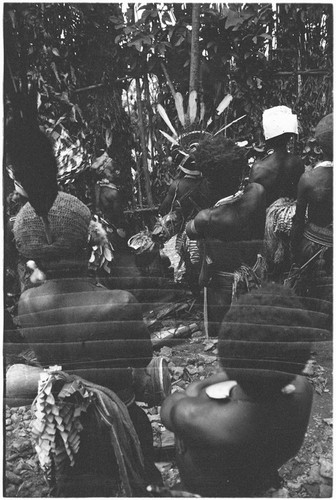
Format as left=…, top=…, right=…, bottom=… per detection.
left=250, top=106, right=304, bottom=281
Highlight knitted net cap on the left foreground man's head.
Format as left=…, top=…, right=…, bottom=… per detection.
left=13, top=192, right=91, bottom=269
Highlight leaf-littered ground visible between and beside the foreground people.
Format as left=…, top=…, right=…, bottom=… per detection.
left=3, top=238, right=333, bottom=498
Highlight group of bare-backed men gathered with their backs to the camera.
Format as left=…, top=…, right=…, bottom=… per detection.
left=3, top=102, right=333, bottom=497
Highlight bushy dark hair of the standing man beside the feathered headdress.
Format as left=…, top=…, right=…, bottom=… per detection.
left=193, top=135, right=247, bottom=202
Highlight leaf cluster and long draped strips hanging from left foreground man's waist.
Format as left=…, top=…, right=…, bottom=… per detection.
left=32, top=367, right=145, bottom=497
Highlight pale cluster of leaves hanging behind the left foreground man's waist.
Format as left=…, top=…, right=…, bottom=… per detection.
left=32, top=372, right=92, bottom=484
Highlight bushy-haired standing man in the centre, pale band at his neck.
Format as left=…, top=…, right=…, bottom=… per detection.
left=186, top=136, right=266, bottom=336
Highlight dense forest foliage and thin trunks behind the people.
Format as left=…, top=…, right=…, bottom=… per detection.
left=3, top=3, right=333, bottom=212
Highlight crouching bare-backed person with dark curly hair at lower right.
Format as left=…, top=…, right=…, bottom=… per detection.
left=161, top=284, right=331, bottom=497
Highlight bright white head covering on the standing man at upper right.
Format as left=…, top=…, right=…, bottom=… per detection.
left=263, top=106, right=298, bottom=144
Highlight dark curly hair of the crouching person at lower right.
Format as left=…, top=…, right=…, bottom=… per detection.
left=218, top=284, right=330, bottom=392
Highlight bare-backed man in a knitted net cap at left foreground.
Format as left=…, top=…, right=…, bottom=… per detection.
left=14, top=192, right=161, bottom=496
